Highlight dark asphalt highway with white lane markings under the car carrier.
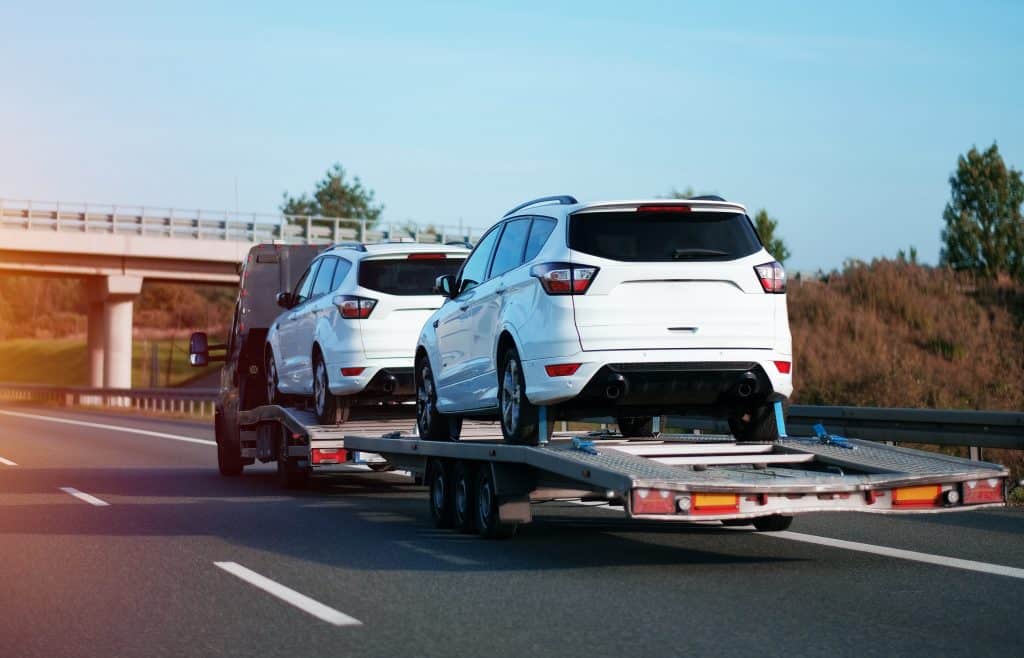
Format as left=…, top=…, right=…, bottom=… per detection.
left=0, top=406, right=1024, bottom=658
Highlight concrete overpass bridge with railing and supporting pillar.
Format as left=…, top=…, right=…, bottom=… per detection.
left=0, top=199, right=481, bottom=388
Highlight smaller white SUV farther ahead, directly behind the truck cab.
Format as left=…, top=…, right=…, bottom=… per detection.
left=265, top=244, right=469, bottom=423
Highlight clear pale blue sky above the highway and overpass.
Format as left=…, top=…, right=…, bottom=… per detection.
left=0, top=0, right=1024, bottom=270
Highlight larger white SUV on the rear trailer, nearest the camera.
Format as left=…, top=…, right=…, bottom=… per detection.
left=416, top=196, right=793, bottom=443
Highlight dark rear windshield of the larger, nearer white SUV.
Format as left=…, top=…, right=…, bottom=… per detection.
left=569, top=211, right=761, bottom=261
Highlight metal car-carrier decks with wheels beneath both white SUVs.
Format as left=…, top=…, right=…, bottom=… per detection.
left=232, top=405, right=1009, bottom=537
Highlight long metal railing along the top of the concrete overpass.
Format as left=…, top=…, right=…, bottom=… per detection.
left=0, top=199, right=483, bottom=245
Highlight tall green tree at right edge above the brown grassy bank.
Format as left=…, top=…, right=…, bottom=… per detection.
left=939, top=142, right=1024, bottom=279
